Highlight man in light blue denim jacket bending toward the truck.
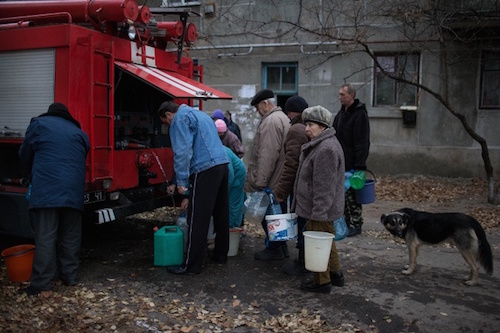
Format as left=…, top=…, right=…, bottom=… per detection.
left=158, top=101, right=229, bottom=275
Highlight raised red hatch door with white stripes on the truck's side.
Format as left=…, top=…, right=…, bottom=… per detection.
left=115, top=61, right=233, bottom=99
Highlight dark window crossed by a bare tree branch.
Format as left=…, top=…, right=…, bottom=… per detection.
left=373, top=54, right=420, bottom=106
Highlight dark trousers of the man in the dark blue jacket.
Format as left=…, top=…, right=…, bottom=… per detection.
left=30, top=208, right=82, bottom=290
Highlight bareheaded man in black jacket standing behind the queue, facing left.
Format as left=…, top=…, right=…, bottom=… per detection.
left=333, top=84, right=370, bottom=237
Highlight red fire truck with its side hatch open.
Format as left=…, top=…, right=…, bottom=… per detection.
left=0, top=0, right=232, bottom=237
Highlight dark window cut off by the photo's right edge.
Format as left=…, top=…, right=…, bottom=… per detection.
left=479, top=51, right=500, bottom=109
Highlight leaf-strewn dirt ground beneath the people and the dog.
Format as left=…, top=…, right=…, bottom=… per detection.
left=0, top=177, right=500, bottom=333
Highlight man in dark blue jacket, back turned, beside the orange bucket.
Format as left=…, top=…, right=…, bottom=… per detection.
left=19, top=103, right=90, bottom=295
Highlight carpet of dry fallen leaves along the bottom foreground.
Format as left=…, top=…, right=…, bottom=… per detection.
left=0, top=278, right=374, bottom=333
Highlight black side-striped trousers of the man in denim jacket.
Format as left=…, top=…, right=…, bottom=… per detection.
left=184, top=164, right=229, bottom=273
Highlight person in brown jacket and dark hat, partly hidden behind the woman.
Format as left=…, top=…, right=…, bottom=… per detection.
left=274, top=96, right=310, bottom=276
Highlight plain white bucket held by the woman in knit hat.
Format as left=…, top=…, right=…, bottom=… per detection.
left=304, top=231, right=335, bottom=272
